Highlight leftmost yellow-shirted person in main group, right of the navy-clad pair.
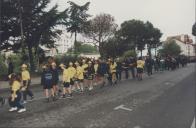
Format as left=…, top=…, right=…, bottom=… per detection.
left=59, top=64, right=72, bottom=98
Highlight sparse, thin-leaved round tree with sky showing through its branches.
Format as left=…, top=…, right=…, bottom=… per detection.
left=84, top=13, right=117, bottom=57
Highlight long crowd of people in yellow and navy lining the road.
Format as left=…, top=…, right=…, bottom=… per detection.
left=0, top=56, right=188, bottom=113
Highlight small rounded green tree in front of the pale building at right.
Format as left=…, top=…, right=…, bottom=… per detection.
left=159, top=40, right=181, bottom=56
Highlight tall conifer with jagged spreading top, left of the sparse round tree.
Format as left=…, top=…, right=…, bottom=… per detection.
left=66, top=1, right=90, bottom=51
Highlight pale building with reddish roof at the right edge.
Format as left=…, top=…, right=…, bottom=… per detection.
left=165, top=35, right=196, bottom=57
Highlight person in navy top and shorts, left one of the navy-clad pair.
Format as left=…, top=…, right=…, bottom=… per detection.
left=41, top=65, right=56, bottom=102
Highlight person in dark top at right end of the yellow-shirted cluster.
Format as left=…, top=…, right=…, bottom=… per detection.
left=87, top=61, right=95, bottom=91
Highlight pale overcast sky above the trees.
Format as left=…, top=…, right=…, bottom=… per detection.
left=52, top=0, right=195, bottom=40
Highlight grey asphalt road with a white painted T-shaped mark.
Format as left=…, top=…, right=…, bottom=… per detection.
left=0, top=64, right=196, bottom=128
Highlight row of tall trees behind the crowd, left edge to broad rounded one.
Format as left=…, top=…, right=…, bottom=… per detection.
left=0, top=0, right=162, bottom=71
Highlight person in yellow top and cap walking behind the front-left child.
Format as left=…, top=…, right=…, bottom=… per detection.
left=21, top=64, right=34, bottom=103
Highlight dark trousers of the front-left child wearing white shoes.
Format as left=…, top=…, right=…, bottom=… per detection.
left=9, top=92, right=24, bottom=109
